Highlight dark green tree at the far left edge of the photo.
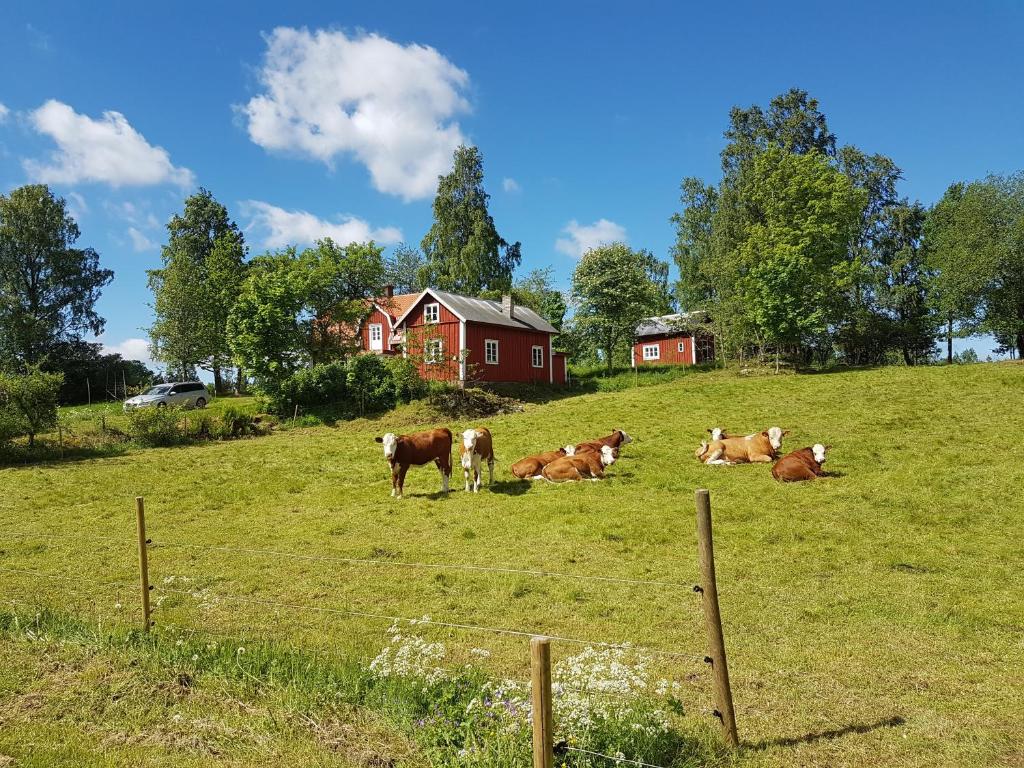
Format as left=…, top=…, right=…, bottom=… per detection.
left=0, top=184, right=114, bottom=370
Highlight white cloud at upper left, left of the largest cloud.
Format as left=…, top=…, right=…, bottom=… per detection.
left=25, top=99, right=196, bottom=186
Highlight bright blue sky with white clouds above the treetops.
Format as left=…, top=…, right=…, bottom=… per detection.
left=0, top=0, right=1024, bottom=359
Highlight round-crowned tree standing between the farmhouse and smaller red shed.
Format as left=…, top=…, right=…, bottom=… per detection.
left=572, top=243, right=664, bottom=373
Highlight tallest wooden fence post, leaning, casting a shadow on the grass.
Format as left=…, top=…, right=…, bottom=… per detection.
left=696, top=488, right=739, bottom=748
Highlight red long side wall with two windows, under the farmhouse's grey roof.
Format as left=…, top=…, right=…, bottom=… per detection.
left=466, top=323, right=551, bottom=384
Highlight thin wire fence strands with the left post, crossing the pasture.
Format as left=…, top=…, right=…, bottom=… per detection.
left=0, top=489, right=731, bottom=768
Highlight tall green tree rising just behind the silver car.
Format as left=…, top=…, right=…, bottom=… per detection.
left=150, top=188, right=246, bottom=392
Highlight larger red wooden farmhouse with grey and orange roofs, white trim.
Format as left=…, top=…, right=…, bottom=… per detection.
left=359, top=288, right=567, bottom=384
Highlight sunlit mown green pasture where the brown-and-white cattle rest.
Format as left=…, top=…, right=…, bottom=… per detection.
left=0, top=364, right=1024, bottom=768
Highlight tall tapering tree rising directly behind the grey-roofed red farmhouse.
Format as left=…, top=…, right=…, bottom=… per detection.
left=421, top=146, right=521, bottom=296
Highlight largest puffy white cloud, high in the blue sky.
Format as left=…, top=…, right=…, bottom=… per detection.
left=240, top=27, right=470, bottom=201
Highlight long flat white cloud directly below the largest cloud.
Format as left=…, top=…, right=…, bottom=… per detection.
left=240, top=200, right=402, bottom=248
